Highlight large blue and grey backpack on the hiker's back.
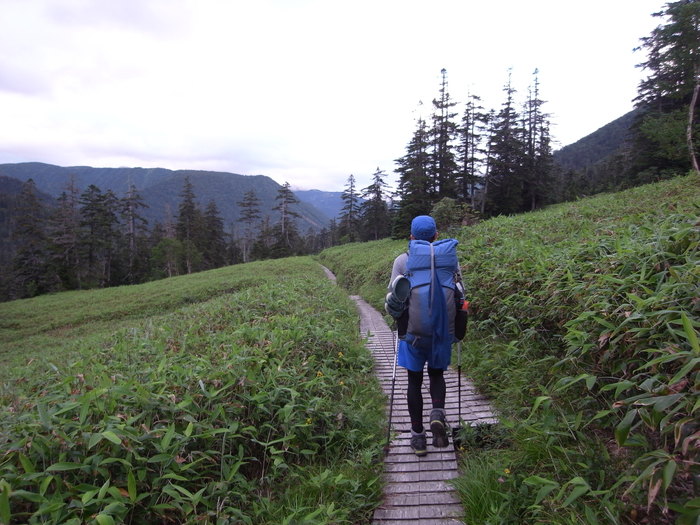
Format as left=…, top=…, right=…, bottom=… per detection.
left=405, top=239, right=463, bottom=368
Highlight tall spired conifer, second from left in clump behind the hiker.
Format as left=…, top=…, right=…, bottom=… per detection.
left=430, top=69, right=457, bottom=202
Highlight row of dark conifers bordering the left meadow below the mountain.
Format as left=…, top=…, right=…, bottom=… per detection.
left=0, top=170, right=389, bottom=300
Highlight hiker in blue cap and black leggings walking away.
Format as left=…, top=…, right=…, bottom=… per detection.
left=385, top=215, right=459, bottom=456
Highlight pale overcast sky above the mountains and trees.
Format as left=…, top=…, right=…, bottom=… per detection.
left=0, top=0, right=665, bottom=191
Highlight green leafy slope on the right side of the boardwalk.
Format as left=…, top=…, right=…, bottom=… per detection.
left=320, top=175, right=700, bottom=525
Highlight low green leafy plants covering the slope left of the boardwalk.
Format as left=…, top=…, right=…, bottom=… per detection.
left=0, top=258, right=384, bottom=525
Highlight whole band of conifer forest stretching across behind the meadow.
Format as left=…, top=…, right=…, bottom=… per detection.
left=0, top=0, right=700, bottom=300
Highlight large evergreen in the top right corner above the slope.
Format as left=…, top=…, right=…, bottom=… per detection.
left=636, top=0, right=700, bottom=174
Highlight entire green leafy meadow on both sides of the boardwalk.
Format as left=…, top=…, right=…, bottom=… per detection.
left=0, top=173, right=700, bottom=525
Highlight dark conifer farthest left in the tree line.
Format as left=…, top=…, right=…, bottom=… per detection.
left=12, top=179, right=52, bottom=298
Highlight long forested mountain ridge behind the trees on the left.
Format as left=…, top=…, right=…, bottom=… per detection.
left=0, top=162, right=330, bottom=234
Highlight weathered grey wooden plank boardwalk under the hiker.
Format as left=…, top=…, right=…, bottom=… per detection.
left=351, top=296, right=496, bottom=525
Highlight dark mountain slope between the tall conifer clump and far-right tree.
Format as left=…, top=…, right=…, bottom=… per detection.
left=554, top=109, right=640, bottom=170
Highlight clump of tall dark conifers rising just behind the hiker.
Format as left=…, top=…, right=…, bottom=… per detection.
left=393, top=69, right=555, bottom=236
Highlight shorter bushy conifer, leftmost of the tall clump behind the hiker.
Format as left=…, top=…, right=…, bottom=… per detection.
left=392, top=118, right=433, bottom=239
